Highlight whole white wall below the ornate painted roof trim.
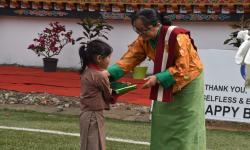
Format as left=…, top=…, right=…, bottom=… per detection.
left=0, top=16, right=237, bottom=72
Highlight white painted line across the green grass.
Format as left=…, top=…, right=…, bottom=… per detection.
left=0, top=126, right=150, bottom=145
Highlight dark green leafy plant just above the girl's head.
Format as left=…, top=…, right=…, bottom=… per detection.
left=76, top=18, right=113, bottom=44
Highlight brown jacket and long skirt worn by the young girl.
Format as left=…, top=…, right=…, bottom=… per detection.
left=80, top=66, right=111, bottom=150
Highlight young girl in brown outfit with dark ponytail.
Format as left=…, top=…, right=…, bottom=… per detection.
left=79, top=40, right=114, bottom=150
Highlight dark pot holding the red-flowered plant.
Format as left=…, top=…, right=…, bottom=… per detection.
left=43, top=58, right=58, bottom=72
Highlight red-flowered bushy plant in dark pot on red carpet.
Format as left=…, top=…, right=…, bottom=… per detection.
left=28, top=22, right=74, bottom=72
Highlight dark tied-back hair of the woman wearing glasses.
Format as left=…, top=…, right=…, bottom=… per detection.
left=131, top=8, right=172, bottom=27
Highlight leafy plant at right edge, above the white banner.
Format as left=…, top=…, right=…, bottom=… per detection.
left=224, top=16, right=250, bottom=47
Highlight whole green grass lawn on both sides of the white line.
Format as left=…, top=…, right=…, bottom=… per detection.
left=0, top=109, right=250, bottom=150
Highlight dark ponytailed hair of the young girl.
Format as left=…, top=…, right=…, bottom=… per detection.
left=79, top=39, right=113, bottom=74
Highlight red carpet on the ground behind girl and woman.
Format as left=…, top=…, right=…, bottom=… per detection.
left=0, top=66, right=150, bottom=106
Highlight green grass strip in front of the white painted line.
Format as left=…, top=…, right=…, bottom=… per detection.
left=0, top=129, right=149, bottom=150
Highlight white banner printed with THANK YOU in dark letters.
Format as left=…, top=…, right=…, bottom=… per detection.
left=199, top=49, right=250, bottom=123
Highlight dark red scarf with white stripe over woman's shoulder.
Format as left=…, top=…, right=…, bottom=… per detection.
left=150, top=26, right=196, bottom=102
